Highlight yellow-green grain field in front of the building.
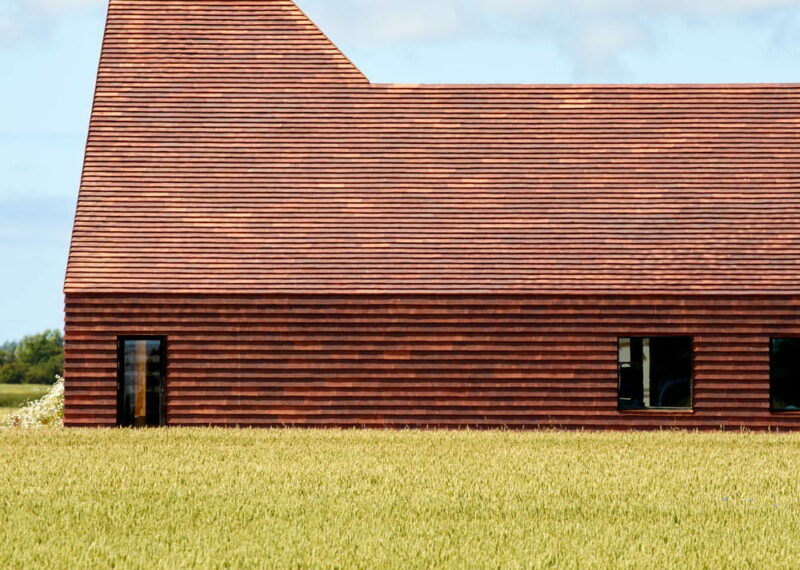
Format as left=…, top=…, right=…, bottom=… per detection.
left=0, top=429, right=800, bottom=569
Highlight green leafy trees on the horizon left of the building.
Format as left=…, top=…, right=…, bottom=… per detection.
left=0, top=330, right=64, bottom=384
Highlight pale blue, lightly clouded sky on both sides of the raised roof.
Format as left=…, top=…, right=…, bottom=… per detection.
left=0, top=0, right=800, bottom=344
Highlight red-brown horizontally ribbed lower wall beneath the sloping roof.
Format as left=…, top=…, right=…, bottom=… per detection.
left=66, top=293, right=800, bottom=429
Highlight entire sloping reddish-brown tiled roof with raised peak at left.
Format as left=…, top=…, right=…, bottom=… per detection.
left=66, top=0, right=800, bottom=294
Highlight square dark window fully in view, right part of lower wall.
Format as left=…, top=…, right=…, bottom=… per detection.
left=619, top=337, right=692, bottom=410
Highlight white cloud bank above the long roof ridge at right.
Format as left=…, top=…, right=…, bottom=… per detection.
left=298, top=0, right=800, bottom=77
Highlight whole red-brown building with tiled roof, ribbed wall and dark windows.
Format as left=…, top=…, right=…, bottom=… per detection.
left=65, top=0, right=800, bottom=429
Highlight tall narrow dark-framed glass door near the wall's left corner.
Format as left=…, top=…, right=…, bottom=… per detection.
left=119, top=338, right=166, bottom=427
